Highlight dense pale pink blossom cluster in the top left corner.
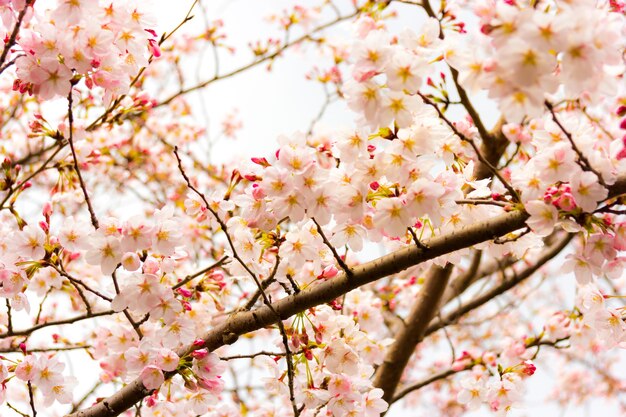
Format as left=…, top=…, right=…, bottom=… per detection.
left=9, top=0, right=160, bottom=100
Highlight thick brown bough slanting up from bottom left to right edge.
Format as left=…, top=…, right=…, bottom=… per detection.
left=67, top=176, right=626, bottom=417
